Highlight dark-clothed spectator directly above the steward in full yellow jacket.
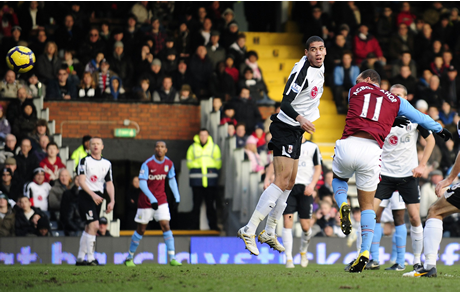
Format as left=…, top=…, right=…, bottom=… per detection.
left=189, top=46, right=213, bottom=99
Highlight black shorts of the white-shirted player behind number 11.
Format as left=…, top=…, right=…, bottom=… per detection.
left=375, top=175, right=420, bottom=204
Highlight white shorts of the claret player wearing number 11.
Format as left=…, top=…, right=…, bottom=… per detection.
left=332, top=136, right=382, bottom=192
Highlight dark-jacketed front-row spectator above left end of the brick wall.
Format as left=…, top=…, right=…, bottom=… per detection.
left=46, top=68, right=79, bottom=100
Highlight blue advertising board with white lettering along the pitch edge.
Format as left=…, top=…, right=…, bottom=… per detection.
left=0, top=236, right=460, bottom=265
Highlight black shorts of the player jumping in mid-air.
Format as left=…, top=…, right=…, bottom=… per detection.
left=268, top=115, right=305, bottom=159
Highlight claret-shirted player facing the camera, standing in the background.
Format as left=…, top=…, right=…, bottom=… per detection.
left=125, top=141, right=182, bottom=267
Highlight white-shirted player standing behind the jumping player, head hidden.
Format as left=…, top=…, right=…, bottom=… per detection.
left=283, top=135, right=321, bottom=268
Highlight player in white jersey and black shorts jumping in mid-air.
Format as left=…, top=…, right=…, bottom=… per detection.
left=238, top=36, right=326, bottom=255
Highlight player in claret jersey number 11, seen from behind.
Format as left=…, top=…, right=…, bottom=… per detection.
left=332, top=69, right=452, bottom=273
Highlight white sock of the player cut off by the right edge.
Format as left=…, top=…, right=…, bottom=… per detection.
left=423, top=218, right=442, bottom=270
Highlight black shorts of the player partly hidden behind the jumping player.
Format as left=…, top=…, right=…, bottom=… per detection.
left=283, top=184, right=313, bottom=219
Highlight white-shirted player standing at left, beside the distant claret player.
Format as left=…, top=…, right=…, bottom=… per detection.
left=76, top=137, right=115, bottom=266
